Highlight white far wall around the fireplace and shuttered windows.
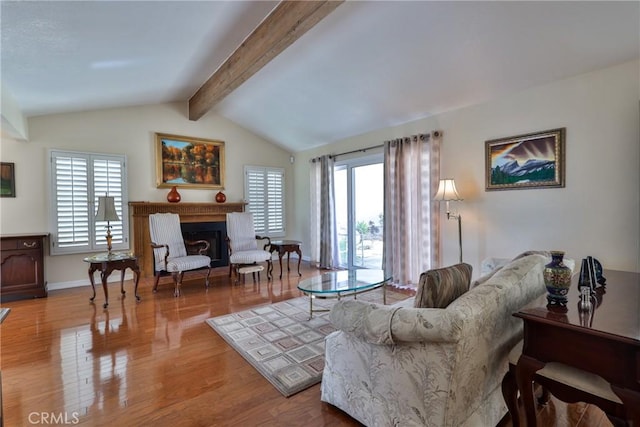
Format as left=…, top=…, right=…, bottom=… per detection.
left=0, top=102, right=295, bottom=289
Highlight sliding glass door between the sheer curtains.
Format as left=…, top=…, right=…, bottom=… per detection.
left=334, top=154, right=384, bottom=268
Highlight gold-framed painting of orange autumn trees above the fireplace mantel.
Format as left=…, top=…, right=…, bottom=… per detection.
left=155, top=133, right=224, bottom=189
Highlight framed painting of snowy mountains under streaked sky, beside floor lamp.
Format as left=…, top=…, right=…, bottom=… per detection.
left=485, top=128, right=565, bottom=191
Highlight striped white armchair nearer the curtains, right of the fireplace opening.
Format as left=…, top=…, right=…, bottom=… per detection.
left=227, top=212, right=273, bottom=280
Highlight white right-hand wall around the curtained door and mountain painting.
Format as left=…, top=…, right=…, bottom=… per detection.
left=294, top=61, right=640, bottom=274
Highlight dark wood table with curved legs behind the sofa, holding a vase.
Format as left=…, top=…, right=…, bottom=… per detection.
left=514, top=270, right=640, bottom=427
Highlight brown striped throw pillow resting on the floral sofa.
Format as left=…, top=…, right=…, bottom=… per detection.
left=414, top=263, right=473, bottom=308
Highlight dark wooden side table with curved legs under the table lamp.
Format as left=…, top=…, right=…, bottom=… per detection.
left=84, top=252, right=140, bottom=308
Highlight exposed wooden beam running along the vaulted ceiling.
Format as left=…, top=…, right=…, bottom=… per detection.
left=189, top=0, right=344, bottom=120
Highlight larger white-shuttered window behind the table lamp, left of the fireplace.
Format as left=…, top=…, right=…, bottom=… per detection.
left=50, top=150, right=129, bottom=255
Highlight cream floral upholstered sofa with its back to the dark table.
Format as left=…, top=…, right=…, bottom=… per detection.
left=321, top=254, right=572, bottom=427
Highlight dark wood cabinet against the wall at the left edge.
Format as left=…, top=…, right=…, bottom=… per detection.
left=0, top=233, right=48, bottom=301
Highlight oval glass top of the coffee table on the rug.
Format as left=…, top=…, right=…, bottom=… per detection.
left=298, top=269, right=391, bottom=294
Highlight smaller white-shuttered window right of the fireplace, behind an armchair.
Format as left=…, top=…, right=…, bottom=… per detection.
left=244, top=166, right=285, bottom=237
